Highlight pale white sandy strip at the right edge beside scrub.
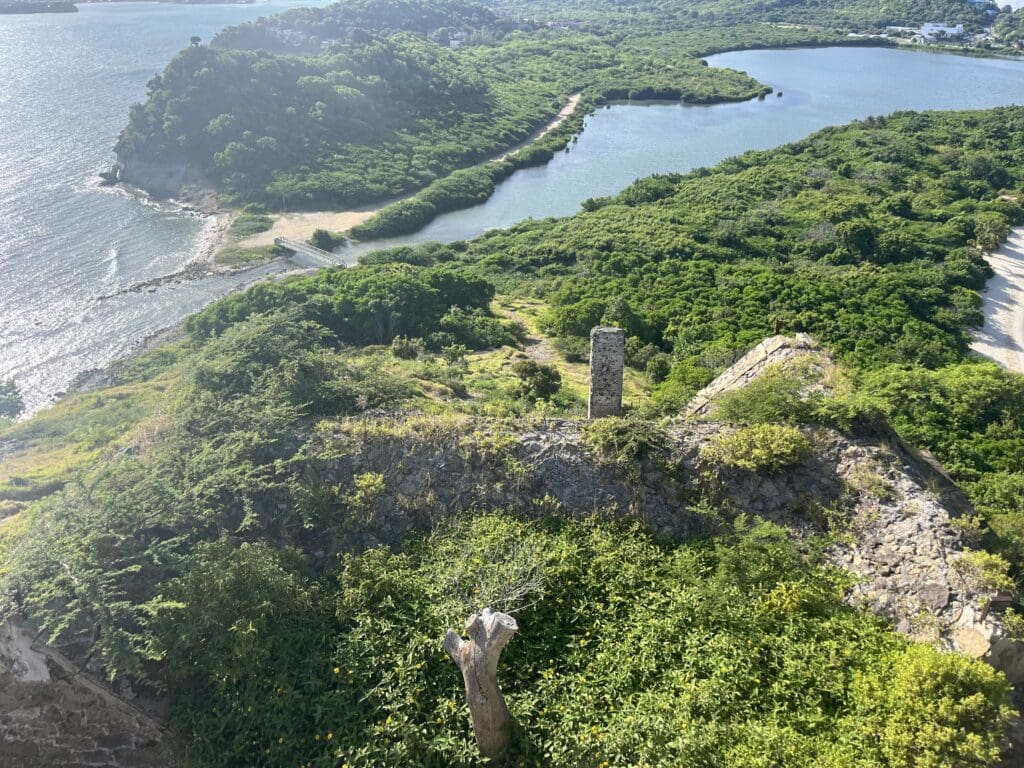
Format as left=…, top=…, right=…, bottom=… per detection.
left=971, top=227, right=1024, bottom=373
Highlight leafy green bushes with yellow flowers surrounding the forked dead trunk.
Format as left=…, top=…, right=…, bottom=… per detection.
left=153, top=515, right=1012, bottom=768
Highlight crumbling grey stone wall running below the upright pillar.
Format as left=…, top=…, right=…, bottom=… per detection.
left=292, top=411, right=1024, bottom=680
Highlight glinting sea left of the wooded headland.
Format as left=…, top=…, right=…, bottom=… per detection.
left=0, top=0, right=316, bottom=410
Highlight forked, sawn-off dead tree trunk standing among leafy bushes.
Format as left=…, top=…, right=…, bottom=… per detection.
left=444, top=608, right=519, bottom=763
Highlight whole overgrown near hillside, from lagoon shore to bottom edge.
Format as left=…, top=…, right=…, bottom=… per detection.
left=6, top=105, right=1024, bottom=768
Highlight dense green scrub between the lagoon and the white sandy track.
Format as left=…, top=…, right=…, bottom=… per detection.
left=447, top=109, right=1024, bottom=385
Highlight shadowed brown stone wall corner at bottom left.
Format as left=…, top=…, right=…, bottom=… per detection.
left=0, top=621, right=171, bottom=768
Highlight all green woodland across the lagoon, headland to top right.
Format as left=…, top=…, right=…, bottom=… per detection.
left=117, top=0, right=1019, bottom=240
